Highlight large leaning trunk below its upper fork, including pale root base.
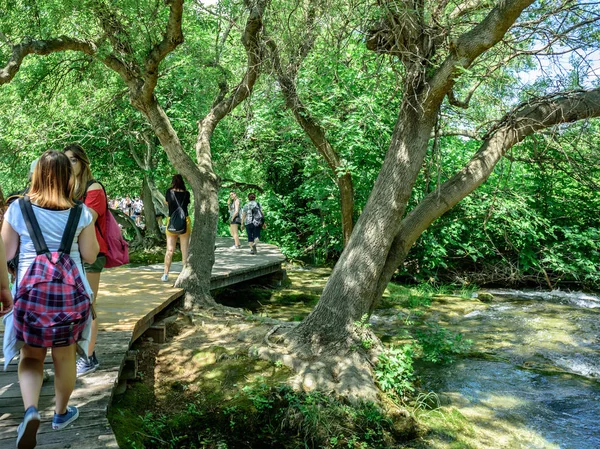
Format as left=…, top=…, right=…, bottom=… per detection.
left=261, top=89, right=437, bottom=401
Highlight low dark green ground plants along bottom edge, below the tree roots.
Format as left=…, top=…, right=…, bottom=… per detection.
left=116, top=382, right=412, bottom=449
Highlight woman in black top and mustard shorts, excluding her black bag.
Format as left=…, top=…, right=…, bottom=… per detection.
left=160, top=174, right=192, bottom=282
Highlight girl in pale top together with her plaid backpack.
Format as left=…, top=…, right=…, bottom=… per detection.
left=1, top=151, right=99, bottom=449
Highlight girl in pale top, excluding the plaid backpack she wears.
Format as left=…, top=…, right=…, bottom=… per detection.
left=2, top=151, right=98, bottom=448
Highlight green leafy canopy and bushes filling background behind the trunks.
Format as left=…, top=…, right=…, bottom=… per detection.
left=0, top=0, right=600, bottom=290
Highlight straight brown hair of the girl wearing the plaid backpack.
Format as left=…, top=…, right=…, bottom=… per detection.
left=28, top=150, right=74, bottom=210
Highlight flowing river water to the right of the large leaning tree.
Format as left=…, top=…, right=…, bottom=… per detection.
left=394, top=290, right=600, bottom=449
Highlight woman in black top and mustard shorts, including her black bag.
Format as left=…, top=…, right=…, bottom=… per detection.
left=160, top=174, right=192, bottom=282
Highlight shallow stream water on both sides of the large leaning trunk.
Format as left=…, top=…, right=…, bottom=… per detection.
left=226, top=269, right=600, bottom=449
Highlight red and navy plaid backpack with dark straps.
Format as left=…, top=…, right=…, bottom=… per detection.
left=14, top=196, right=90, bottom=348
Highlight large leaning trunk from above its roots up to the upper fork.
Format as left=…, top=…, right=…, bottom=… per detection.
left=293, top=96, right=437, bottom=346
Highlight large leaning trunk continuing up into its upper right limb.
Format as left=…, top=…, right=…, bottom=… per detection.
left=290, top=0, right=548, bottom=346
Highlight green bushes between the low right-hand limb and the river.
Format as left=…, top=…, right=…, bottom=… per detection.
left=400, top=120, right=600, bottom=289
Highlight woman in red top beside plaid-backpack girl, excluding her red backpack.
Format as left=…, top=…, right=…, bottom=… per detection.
left=63, top=144, right=110, bottom=377
